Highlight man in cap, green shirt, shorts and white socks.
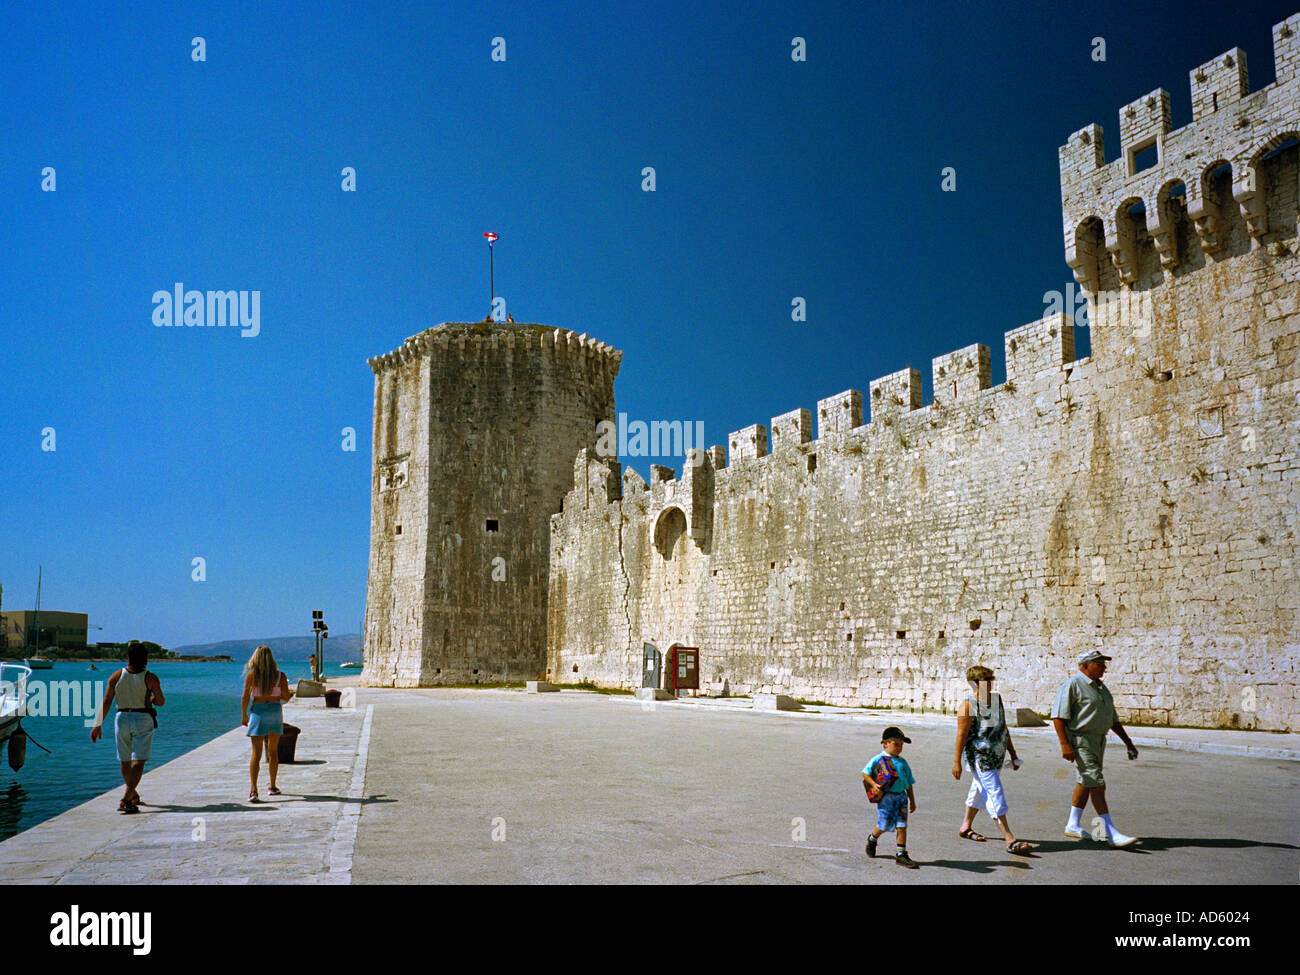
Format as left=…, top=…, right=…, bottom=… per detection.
left=1052, top=650, right=1138, bottom=846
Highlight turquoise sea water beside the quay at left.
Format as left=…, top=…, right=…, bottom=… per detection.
left=0, top=660, right=359, bottom=842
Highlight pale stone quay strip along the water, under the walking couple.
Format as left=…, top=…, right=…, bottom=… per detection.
left=0, top=699, right=377, bottom=884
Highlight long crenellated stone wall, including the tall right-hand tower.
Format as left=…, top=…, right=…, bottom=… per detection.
left=547, top=14, right=1300, bottom=729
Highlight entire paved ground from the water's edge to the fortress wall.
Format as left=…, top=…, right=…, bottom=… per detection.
left=0, top=679, right=1300, bottom=884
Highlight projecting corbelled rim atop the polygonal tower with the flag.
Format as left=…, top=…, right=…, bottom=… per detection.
left=365, top=322, right=623, bottom=380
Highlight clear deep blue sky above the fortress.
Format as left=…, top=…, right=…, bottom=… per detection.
left=0, top=0, right=1300, bottom=646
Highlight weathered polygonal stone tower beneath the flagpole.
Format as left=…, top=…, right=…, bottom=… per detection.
left=361, top=322, right=623, bottom=688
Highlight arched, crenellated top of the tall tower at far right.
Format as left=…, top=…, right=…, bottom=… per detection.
left=1058, top=13, right=1300, bottom=294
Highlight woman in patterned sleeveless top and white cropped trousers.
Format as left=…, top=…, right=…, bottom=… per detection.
left=953, top=666, right=1034, bottom=855
